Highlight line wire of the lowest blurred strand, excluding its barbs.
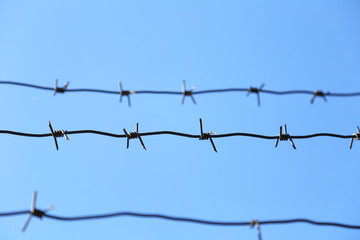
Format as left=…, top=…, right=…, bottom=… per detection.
left=0, top=210, right=360, bottom=230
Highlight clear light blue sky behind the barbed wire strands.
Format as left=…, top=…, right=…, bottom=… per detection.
left=0, top=0, right=360, bottom=240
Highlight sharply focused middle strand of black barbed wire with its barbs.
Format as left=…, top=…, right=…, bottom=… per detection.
left=0, top=118, right=360, bottom=152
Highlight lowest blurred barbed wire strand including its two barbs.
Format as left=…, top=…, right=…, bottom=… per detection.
left=0, top=191, right=360, bottom=234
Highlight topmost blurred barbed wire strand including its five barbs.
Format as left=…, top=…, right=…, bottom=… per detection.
left=0, top=79, right=360, bottom=106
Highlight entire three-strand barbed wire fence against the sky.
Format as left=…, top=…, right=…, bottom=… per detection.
left=0, top=80, right=360, bottom=240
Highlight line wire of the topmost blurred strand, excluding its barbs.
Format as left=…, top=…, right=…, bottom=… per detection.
left=0, top=81, right=360, bottom=97
